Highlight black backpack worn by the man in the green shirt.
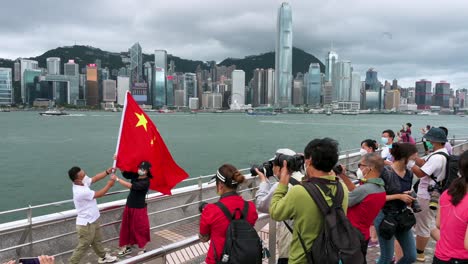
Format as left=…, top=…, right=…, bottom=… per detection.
left=298, top=178, right=365, bottom=264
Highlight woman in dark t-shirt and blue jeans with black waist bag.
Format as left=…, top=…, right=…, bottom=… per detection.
left=374, top=143, right=417, bottom=264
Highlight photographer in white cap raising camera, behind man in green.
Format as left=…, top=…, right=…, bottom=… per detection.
left=251, top=149, right=304, bottom=264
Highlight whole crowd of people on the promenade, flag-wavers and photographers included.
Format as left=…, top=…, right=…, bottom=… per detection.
left=4, top=123, right=468, bottom=264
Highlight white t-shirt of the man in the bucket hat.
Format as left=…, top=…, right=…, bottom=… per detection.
left=418, top=148, right=448, bottom=199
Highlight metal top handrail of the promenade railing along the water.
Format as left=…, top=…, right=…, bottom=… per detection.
left=0, top=135, right=468, bottom=222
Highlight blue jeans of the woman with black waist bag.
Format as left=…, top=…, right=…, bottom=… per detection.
left=374, top=211, right=416, bottom=264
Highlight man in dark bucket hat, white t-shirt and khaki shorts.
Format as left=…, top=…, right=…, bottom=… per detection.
left=411, top=127, right=448, bottom=261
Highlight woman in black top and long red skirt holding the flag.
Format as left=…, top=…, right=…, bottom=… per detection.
left=112, top=161, right=153, bottom=256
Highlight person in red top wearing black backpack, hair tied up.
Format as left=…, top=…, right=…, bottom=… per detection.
left=199, top=164, right=261, bottom=264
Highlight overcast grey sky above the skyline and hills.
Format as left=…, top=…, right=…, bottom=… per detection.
left=0, top=0, right=468, bottom=89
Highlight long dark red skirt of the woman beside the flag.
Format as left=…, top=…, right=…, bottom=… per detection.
left=119, top=206, right=151, bottom=248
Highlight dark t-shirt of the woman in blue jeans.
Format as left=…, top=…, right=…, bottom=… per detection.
left=380, top=166, right=413, bottom=211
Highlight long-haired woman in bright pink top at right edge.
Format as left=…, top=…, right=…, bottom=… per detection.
left=432, top=151, right=468, bottom=264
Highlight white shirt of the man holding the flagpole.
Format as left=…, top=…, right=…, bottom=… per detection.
left=73, top=175, right=100, bottom=225
